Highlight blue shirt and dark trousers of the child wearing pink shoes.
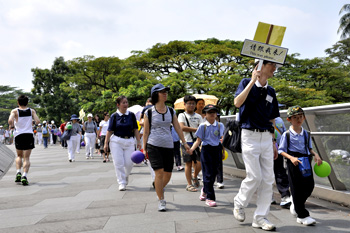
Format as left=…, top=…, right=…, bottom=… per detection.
left=196, top=121, right=225, bottom=201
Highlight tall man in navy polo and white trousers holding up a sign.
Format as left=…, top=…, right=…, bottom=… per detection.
left=233, top=61, right=280, bottom=231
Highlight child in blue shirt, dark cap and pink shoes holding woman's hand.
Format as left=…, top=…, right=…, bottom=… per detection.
left=190, top=104, right=224, bottom=207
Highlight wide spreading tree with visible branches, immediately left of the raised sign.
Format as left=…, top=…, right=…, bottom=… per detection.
left=127, top=38, right=253, bottom=113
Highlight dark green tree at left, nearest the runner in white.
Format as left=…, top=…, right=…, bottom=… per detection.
left=32, top=57, right=80, bottom=123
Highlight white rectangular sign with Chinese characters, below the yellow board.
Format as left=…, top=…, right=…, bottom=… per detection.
left=241, top=39, right=288, bottom=65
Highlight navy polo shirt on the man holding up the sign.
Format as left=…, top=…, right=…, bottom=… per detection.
left=235, top=78, right=280, bottom=130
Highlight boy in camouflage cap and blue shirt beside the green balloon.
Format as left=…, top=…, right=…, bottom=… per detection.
left=278, top=105, right=322, bottom=226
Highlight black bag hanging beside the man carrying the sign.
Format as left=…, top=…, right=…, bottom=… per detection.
left=222, top=109, right=242, bottom=153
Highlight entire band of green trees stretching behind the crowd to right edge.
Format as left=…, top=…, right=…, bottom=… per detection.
left=26, top=38, right=350, bottom=120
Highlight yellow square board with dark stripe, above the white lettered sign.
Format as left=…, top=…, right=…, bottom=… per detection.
left=254, top=22, right=286, bottom=46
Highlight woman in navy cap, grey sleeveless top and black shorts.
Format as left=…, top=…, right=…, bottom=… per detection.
left=143, top=83, right=190, bottom=211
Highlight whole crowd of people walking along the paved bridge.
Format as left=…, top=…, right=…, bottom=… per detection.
left=4, top=61, right=322, bottom=231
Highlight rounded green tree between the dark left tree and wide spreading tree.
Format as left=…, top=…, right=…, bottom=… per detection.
left=62, top=56, right=156, bottom=113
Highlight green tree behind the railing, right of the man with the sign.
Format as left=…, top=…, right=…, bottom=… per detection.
left=269, top=54, right=350, bottom=107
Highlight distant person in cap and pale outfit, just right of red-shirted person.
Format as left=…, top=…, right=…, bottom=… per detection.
left=65, top=114, right=81, bottom=162
